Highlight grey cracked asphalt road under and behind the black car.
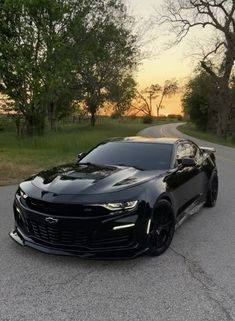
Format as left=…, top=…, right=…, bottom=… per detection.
left=0, top=125, right=235, bottom=321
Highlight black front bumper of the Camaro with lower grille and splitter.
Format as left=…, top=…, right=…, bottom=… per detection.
left=9, top=196, right=148, bottom=259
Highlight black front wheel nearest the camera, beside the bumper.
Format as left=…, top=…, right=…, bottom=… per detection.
left=148, top=200, right=175, bottom=256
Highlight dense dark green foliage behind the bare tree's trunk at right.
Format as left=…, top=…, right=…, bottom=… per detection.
left=182, top=68, right=235, bottom=138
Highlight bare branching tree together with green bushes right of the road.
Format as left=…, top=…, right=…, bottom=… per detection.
left=158, top=0, right=235, bottom=138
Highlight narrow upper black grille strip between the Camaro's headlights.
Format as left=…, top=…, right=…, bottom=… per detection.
left=25, top=197, right=108, bottom=217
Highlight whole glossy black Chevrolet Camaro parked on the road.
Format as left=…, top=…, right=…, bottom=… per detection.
left=10, top=137, right=218, bottom=258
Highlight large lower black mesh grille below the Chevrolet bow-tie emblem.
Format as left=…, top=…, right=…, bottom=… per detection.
left=28, top=220, right=88, bottom=246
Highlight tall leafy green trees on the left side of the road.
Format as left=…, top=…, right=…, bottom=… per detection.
left=0, top=0, right=139, bottom=135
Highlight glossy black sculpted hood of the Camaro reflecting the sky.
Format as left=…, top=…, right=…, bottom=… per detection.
left=28, top=164, right=163, bottom=195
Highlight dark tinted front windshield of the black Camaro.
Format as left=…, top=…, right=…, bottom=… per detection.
left=80, top=141, right=172, bottom=170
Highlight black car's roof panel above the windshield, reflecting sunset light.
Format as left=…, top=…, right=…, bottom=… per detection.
left=108, top=136, right=185, bottom=145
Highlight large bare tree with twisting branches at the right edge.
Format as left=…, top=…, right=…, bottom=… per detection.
left=159, top=0, right=235, bottom=137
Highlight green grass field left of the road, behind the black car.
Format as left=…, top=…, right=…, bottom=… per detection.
left=0, top=118, right=174, bottom=185
